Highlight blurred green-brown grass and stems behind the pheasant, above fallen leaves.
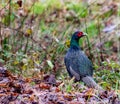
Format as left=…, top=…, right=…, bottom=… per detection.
left=0, top=0, right=120, bottom=89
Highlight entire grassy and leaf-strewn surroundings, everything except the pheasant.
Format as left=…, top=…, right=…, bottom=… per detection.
left=0, top=0, right=120, bottom=104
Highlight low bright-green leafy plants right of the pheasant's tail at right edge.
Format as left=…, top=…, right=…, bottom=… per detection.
left=95, top=61, right=120, bottom=89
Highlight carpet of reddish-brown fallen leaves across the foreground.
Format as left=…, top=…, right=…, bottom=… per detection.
left=0, top=67, right=120, bottom=104
